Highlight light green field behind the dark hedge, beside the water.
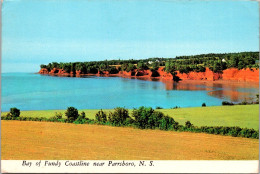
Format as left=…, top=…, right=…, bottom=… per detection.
left=2, top=105, right=259, bottom=129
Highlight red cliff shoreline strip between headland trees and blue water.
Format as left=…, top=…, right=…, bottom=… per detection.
left=38, top=67, right=259, bottom=83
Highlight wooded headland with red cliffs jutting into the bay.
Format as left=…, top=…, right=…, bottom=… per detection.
left=39, top=52, right=259, bottom=82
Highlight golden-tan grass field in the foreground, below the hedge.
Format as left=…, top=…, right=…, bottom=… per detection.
left=1, top=120, right=259, bottom=160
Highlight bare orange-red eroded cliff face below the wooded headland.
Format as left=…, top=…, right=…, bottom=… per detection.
left=39, top=67, right=259, bottom=82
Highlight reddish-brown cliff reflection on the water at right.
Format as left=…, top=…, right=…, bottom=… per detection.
left=129, top=77, right=259, bottom=103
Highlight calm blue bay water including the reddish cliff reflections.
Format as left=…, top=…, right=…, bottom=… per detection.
left=1, top=73, right=258, bottom=111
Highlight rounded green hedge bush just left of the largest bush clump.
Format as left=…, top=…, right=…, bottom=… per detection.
left=108, top=107, right=130, bottom=126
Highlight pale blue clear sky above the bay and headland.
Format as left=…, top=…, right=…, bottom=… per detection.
left=1, top=0, right=259, bottom=72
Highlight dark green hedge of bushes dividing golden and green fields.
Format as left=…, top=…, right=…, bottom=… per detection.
left=1, top=106, right=259, bottom=139
